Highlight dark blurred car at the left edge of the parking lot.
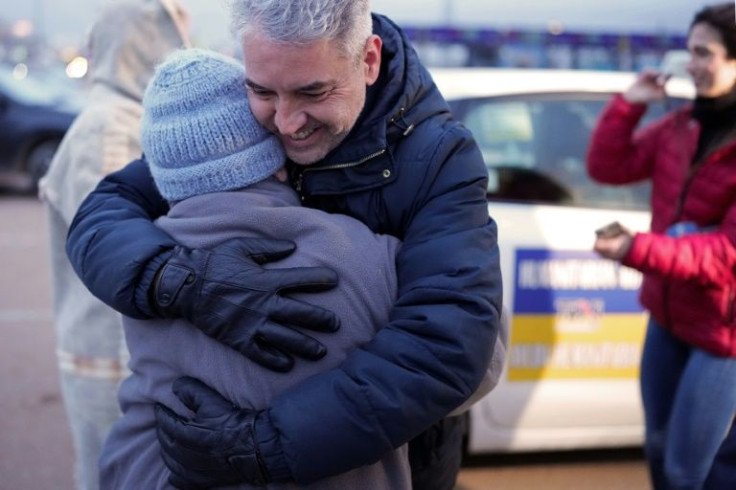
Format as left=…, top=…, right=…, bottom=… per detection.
left=0, top=68, right=82, bottom=190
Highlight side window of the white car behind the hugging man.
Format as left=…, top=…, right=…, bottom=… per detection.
left=451, top=94, right=685, bottom=210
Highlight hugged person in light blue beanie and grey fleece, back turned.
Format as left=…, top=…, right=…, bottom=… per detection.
left=100, top=49, right=411, bottom=490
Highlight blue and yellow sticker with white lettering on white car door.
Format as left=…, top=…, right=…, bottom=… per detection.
left=508, top=249, right=646, bottom=381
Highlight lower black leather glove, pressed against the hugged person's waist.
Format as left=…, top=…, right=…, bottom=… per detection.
left=155, top=377, right=269, bottom=490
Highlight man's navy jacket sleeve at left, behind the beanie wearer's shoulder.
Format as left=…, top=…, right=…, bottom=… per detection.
left=66, top=160, right=176, bottom=318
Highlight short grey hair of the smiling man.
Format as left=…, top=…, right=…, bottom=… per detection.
left=230, top=0, right=373, bottom=57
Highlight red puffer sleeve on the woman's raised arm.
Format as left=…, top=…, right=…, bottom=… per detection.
left=586, top=94, right=667, bottom=184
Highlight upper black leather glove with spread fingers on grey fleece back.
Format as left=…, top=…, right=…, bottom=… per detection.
left=152, top=238, right=339, bottom=372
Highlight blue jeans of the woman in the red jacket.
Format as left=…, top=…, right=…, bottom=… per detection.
left=641, top=320, right=736, bottom=490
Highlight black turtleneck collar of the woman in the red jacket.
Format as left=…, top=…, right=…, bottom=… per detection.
left=692, top=85, right=736, bottom=163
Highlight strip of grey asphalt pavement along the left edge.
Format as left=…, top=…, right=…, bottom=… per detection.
left=0, top=195, right=73, bottom=490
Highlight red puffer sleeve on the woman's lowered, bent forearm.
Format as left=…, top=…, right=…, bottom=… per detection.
left=622, top=203, right=736, bottom=287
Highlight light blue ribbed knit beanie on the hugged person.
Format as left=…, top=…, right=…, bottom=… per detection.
left=141, top=49, right=286, bottom=201
